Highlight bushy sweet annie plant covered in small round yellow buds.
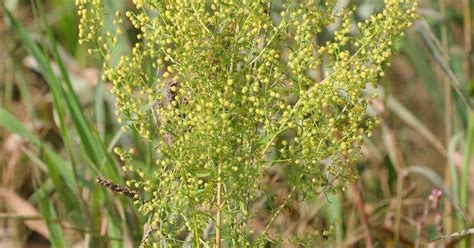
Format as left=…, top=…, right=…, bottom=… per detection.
left=76, top=0, right=416, bottom=247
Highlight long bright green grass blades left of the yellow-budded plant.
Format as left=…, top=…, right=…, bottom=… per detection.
left=0, top=3, right=141, bottom=247
